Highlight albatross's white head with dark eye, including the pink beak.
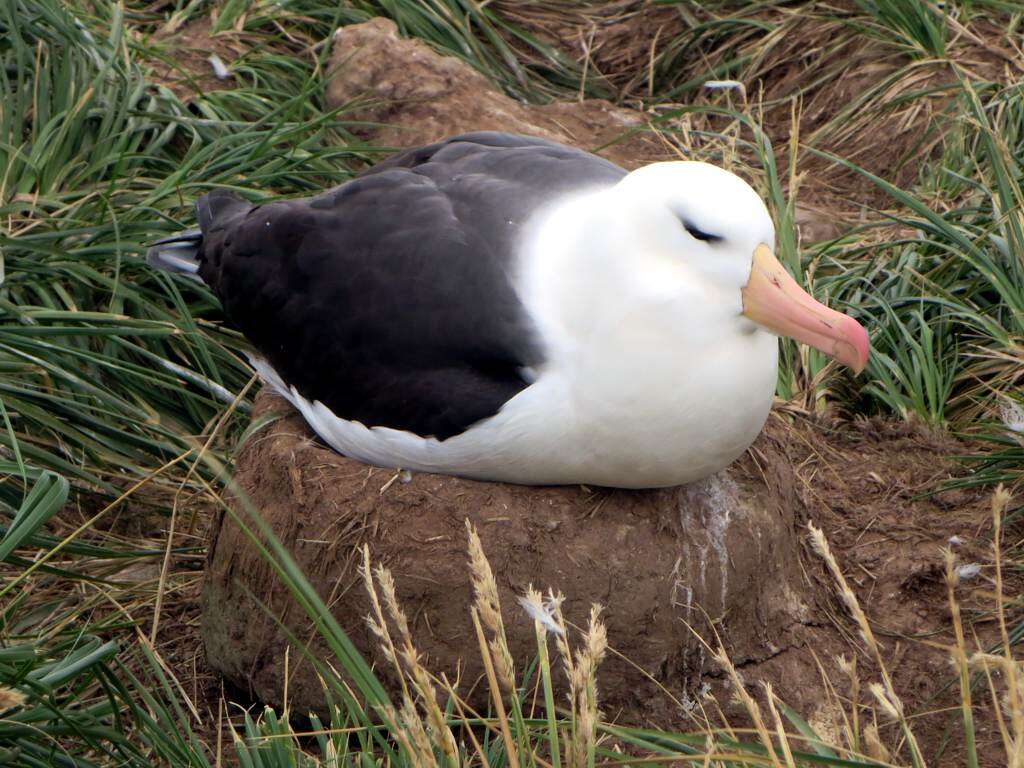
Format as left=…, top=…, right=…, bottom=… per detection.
left=604, top=162, right=870, bottom=373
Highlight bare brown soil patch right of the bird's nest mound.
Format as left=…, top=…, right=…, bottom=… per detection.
left=748, top=416, right=1016, bottom=766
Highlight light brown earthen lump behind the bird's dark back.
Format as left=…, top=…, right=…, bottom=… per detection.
left=327, top=18, right=663, bottom=168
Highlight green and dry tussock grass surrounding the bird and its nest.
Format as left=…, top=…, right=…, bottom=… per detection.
left=0, top=0, right=1024, bottom=766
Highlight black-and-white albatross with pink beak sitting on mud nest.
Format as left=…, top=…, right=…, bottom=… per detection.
left=148, top=132, right=869, bottom=487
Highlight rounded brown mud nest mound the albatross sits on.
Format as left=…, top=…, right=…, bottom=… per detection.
left=201, top=391, right=807, bottom=716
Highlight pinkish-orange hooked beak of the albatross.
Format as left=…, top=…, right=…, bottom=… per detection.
left=742, top=244, right=871, bottom=374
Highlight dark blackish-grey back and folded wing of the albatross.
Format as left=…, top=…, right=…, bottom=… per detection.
left=197, top=132, right=626, bottom=439
